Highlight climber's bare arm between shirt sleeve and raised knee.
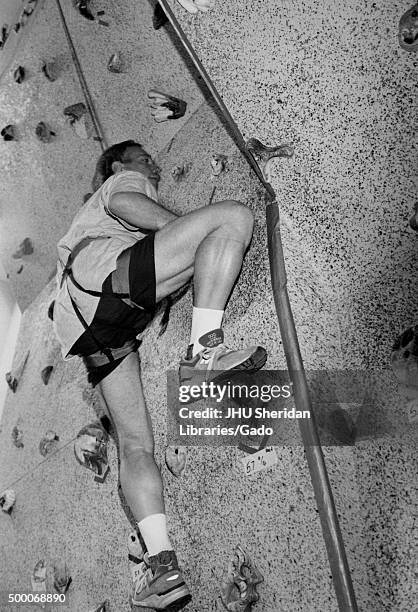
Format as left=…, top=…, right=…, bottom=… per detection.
left=109, top=191, right=177, bottom=230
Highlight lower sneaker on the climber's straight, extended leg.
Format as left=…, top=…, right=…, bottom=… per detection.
left=132, top=550, right=191, bottom=610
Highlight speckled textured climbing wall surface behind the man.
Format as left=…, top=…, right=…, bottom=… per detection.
left=0, top=1, right=418, bottom=612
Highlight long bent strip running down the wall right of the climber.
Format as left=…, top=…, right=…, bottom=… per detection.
left=158, top=0, right=358, bottom=612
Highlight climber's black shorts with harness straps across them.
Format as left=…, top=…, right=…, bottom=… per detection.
left=70, top=233, right=156, bottom=386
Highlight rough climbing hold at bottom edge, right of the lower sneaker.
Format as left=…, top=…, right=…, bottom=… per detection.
left=221, top=546, right=264, bottom=612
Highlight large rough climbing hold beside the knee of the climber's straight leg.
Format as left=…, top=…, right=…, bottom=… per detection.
left=74, top=422, right=110, bottom=482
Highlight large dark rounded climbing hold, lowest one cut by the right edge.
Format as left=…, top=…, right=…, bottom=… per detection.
left=390, top=325, right=418, bottom=387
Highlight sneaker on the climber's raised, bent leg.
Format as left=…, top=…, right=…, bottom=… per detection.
left=179, top=329, right=267, bottom=394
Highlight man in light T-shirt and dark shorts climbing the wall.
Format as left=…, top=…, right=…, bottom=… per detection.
left=53, top=140, right=266, bottom=610
